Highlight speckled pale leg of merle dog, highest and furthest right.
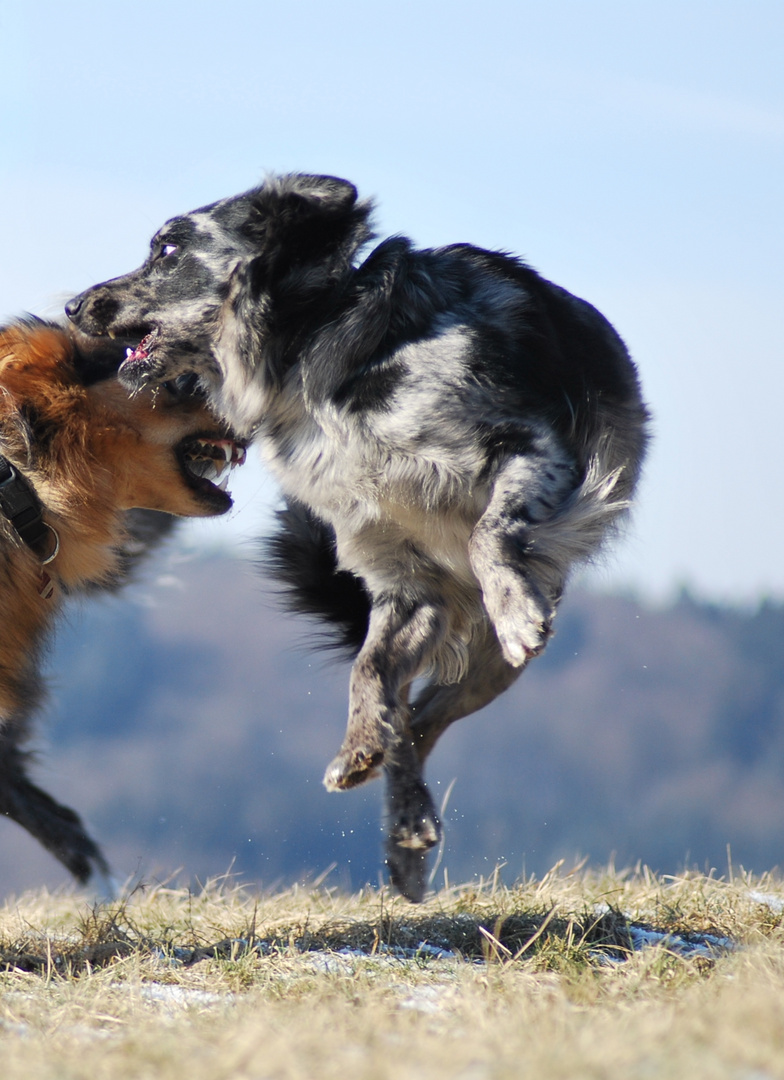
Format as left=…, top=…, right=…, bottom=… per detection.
left=469, top=440, right=576, bottom=667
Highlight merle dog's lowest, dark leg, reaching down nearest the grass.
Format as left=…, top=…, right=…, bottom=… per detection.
left=384, top=626, right=523, bottom=903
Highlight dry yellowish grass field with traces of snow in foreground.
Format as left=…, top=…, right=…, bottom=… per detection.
left=0, top=867, right=784, bottom=1080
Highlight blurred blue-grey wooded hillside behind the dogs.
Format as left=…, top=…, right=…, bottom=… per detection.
left=0, top=552, right=784, bottom=894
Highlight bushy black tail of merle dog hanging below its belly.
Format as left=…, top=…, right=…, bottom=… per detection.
left=261, top=500, right=370, bottom=657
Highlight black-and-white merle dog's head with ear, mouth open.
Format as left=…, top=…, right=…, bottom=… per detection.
left=66, top=174, right=370, bottom=424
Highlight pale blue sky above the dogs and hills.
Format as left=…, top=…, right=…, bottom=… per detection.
left=0, top=0, right=784, bottom=603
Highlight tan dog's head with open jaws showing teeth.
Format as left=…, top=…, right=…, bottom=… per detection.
left=0, top=321, right=245, bottom=517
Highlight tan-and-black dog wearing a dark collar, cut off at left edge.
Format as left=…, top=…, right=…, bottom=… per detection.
left=0, top=320, right=245, bottom=881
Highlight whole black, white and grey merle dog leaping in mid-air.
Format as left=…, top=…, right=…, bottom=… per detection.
left=66, top=174, right=648, bottom=900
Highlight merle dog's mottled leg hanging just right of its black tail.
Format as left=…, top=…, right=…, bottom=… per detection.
left=324, top=597, right=446, bottom=792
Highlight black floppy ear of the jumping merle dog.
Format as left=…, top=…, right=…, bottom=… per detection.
left=243, top=173, right=371, bottom=276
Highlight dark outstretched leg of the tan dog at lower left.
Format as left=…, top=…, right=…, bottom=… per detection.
left=0, top=734, right=113, bottom=892
